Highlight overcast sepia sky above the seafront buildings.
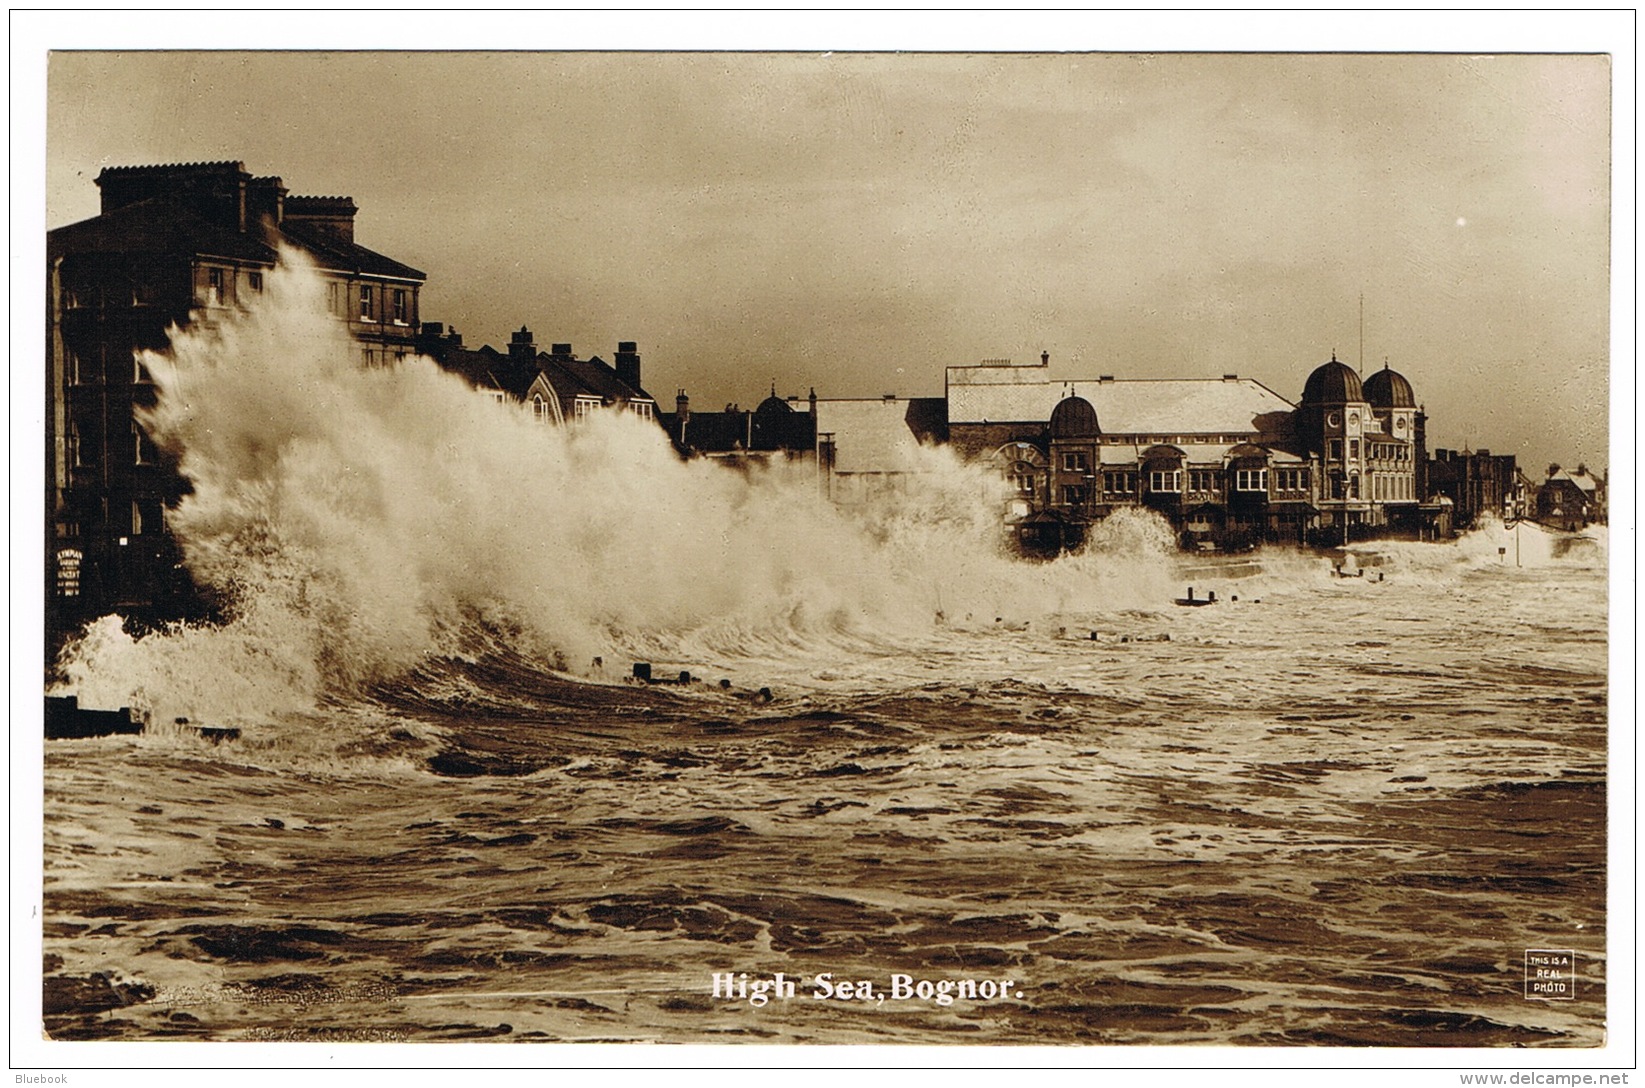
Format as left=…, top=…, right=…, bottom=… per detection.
left=46, top=45, right=1612, bottom=476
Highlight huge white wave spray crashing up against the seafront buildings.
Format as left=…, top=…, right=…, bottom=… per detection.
left=54, top=255, right=1170, bottom=719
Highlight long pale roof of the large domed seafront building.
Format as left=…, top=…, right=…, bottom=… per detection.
left=948, top=367, right=1295, bottom=435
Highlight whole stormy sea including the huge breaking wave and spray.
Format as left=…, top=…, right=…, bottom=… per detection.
left=43, top=258, right=1609, bottom=1047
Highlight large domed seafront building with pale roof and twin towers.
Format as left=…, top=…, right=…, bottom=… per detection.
left=946, top=354, right=1425, bottom=551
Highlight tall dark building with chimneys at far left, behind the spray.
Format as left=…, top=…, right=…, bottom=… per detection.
left=46, top=161, right=424, bottom=647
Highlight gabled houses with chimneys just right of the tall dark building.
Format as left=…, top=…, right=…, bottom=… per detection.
left=418, top=321, right=660, bottom=423
